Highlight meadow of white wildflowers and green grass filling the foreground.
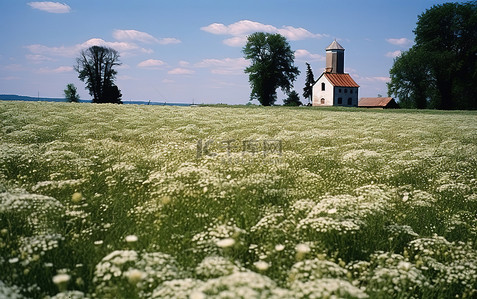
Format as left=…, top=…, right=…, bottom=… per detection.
left=0, top=102, right=477, bottom=299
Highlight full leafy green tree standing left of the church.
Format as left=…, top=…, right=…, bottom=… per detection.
left=243, top=32, right=300, bottom=106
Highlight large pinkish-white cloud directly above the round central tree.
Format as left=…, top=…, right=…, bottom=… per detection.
left=200, top=20, right=327, bottom=47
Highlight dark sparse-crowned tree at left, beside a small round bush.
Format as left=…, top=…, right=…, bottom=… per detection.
left=75, top=46, right=121, bottom=103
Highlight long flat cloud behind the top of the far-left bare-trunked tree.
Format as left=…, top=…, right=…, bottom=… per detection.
left=26, top=38, right=153, bottom=57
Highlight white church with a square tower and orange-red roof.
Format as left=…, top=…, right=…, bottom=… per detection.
left=312, top=40, right=359, bottom=107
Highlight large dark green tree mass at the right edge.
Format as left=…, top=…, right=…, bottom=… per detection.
left=388, top=1, right=477, bottom=109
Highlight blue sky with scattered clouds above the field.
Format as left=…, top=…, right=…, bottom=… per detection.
left=0, top=0, right=446, bottom=104
